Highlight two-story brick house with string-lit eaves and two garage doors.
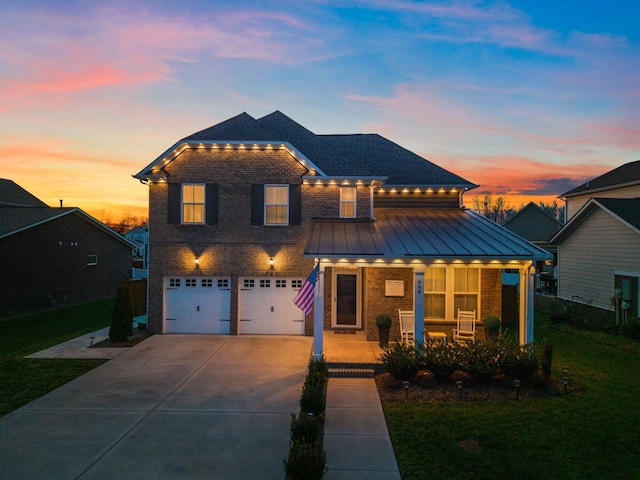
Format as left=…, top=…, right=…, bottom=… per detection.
left=134, top=111, right=551, bottom=355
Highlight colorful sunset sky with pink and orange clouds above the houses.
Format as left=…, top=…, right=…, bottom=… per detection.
left=0, top=0, right=640, bottom=221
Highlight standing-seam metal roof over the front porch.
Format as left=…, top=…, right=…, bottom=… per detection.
left=305, top=208, right=552, bottom=260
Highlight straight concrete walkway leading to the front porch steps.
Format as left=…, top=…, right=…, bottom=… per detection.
left=324, top=378, right=400, bottom=480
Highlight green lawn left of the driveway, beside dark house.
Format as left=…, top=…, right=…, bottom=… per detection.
left=0, top=300, right=114, bottom=416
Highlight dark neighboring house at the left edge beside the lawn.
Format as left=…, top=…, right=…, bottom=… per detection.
left=0, top=179, right=134, bottom=316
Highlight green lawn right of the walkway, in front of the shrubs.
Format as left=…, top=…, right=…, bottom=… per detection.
left=384, top=315, right=640, bottom=480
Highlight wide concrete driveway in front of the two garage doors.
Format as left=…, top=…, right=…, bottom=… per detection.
left=0, top=335, right=312, bottom=480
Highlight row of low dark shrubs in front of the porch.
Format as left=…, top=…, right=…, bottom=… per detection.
left=375, top=372, right=575, bottom=403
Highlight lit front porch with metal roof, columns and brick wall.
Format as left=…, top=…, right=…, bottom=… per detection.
left=305, top=209, right=550, bottom=357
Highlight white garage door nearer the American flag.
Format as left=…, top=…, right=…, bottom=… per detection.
left=238, top=277, right=304, bottom=335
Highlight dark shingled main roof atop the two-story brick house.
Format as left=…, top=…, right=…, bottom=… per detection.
left=139, top=111, right=477, bottom=189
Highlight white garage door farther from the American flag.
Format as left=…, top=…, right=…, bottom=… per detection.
left=164, top=277, right=231, bottom=335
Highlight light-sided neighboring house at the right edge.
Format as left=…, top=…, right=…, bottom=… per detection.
left=551, top=161, right=640, bottom=318
